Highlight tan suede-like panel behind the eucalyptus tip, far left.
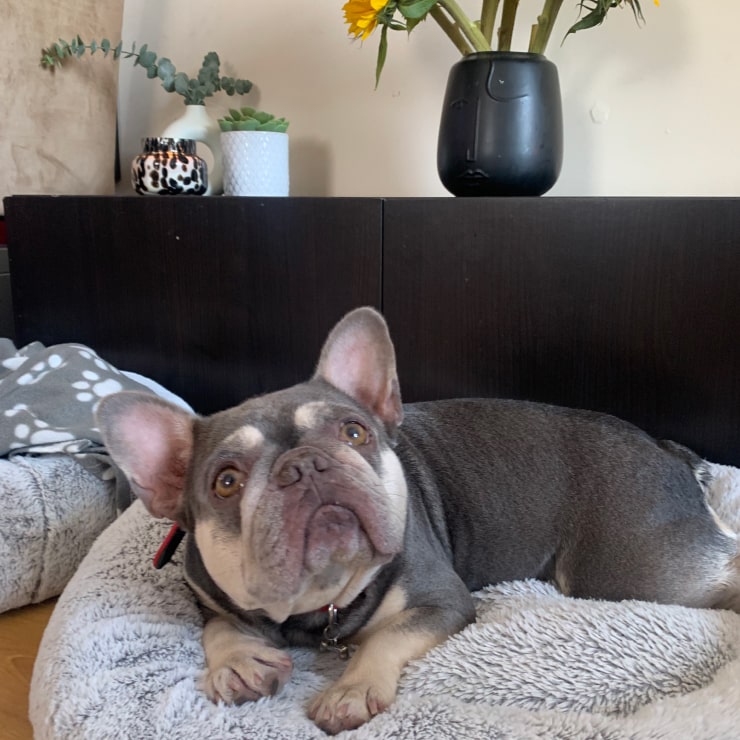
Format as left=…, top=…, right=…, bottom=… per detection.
left=0, top=0, right=123, bottom=214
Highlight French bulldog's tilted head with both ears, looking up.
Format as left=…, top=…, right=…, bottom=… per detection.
left=97, top=308, right=407, bottom=622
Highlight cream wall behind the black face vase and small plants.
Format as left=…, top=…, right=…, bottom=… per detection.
left=114, top=0, right=740, bottom=196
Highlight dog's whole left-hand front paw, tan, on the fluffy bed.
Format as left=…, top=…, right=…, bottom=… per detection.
left=202, top=631, right=293, bottom=704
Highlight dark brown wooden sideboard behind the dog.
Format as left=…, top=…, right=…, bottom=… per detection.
left=5, top=196, right=740, bottom=465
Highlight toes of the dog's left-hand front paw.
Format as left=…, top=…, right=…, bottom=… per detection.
left=203, top=650, right=293, bottom=704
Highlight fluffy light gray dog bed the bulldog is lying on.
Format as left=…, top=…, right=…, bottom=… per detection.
left=31, top=466, right=740, bottom=740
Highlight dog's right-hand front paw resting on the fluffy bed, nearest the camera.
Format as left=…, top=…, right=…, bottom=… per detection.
left=308, top=679, right=395, bottom=735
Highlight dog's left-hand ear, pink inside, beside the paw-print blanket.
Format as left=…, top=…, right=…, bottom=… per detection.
left=96, top=391, right=195, bottom=522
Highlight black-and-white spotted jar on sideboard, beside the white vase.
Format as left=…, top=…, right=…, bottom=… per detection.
left=131, top=138, right=208, bottom=195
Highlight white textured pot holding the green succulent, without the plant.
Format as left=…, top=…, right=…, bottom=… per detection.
left=221, top=131, right=290, bottom=196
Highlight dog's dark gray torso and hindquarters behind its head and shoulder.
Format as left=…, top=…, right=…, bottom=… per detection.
left=396, top=399, right=737, bottom=606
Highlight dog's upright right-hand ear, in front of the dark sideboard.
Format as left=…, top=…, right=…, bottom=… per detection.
left=314, top=307, right=403, bottom=429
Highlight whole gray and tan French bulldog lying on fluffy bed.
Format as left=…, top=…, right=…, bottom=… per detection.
left=98, top=308, right=740, bottom=733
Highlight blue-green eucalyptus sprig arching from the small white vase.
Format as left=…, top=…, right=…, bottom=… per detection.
left=41, top=35, right=252, bottom=105
